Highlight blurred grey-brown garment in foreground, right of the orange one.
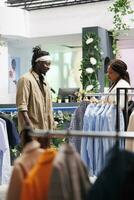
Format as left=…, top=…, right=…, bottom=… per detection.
left=48, top=144, right=90, bottom=200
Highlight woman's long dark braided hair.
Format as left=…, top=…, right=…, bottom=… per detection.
left=110, top=59, right=130, bottom=84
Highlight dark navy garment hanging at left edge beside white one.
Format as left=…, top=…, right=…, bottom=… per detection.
left=0, top=114, right=20, bottom=148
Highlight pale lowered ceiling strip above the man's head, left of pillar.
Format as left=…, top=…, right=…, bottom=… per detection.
left=4, top=34, right=82, bottom=51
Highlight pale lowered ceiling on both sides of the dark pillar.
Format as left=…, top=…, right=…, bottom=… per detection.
left=4, top=29, right=134, bottom=51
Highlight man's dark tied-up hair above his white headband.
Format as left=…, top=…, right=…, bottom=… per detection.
left=31, top=46, right=49, bottom=68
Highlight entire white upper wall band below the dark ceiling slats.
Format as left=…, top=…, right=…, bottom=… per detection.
left=0, top=1, right=134, bottom=37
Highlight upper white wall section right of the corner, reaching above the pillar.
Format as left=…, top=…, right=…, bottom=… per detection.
left=30, top=2, right=112, bottom=37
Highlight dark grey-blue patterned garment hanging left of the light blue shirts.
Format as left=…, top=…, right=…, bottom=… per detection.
left=69, top=101, right=90, bottom=153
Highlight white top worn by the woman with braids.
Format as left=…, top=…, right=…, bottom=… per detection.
left=105, top=79, right=131, bottom=108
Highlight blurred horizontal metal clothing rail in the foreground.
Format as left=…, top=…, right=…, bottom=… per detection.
left=26, top=129, right=134, bottom=139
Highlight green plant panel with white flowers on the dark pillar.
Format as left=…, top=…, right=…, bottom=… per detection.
left=80, top=32, right=103, bottom=92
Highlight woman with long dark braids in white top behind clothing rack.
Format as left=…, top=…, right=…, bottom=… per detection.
left=107, top=59, right=130, bottom=108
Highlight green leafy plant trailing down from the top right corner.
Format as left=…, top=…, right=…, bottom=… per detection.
left=109, top=0, right=134, bottom=55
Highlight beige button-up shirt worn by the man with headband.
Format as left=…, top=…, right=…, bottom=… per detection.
left=16, top=70, right=54, bottom=132
